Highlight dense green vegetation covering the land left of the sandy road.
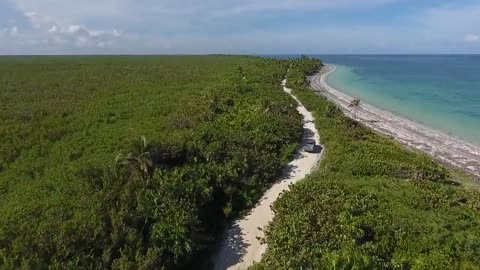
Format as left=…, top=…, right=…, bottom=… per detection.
left=0, top=56, right=302, bottom=269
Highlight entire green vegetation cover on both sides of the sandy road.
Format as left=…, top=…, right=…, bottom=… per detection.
left=4, top=56, right=480, bottom=269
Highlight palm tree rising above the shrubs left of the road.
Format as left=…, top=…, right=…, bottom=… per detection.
left=115, top=136, right=155, bottom=182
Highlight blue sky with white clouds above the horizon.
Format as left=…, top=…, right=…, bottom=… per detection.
left=0, top=0, right=480, bottom=55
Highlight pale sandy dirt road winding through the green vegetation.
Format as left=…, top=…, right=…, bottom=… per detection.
left=214, top=81, right=323, bottom=270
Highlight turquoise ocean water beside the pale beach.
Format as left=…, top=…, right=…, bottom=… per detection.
left=315, top=55, right=480, bottom=145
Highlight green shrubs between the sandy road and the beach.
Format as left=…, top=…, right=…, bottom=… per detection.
left=253, top=59, right=480, bottom=269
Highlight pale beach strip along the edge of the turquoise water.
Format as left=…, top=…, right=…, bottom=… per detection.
left=309, top=65, right=480, bottom=177
